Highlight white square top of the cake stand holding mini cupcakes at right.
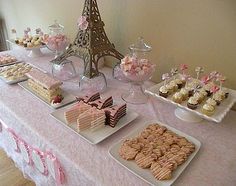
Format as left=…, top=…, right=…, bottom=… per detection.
left=145, top=82, right=236, bottom=123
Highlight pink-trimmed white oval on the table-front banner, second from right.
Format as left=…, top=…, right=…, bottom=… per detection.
left=31, top=148, right=48, bottom=176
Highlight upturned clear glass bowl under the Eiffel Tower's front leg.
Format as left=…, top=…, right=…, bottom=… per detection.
left=79, top=72, right=107, bottom=93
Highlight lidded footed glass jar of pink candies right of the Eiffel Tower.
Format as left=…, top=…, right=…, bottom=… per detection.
left=120, top=38, right=155, bottom=104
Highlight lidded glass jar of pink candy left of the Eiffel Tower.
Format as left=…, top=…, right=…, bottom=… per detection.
left=44, top=21, right=69, bottom=58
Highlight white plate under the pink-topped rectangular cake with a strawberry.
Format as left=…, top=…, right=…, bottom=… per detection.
left=18, top=81, right=76, bottom=109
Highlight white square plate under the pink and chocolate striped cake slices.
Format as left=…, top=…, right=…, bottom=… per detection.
left=51, top=105, right=138, bottom=145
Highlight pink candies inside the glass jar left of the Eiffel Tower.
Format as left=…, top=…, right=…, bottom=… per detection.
left=45, top=34, right=69, bottom=51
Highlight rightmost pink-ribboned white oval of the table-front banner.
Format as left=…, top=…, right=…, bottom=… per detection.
left=46, top=152, right=65, bottom=186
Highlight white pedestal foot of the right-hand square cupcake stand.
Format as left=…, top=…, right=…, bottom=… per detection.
left=175, top=108, right=203, bottom=123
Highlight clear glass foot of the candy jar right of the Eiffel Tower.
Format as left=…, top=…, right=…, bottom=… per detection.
left=121, top=83, right=148, bottom=104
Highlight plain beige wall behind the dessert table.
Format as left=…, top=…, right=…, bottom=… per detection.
left=0, top=0, right=236, bottom=89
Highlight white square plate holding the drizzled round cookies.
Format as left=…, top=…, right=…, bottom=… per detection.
left=109, top=120, right=201, bottom=186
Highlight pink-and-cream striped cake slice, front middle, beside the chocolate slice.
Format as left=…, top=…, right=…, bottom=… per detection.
left=77, top=107, right=106, bottom=131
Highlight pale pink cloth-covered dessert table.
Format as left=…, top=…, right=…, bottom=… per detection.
left=0, top=49, right=236, bottom=186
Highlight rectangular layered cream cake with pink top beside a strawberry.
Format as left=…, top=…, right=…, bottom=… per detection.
left=26, top=69, right=62, bottom=103
